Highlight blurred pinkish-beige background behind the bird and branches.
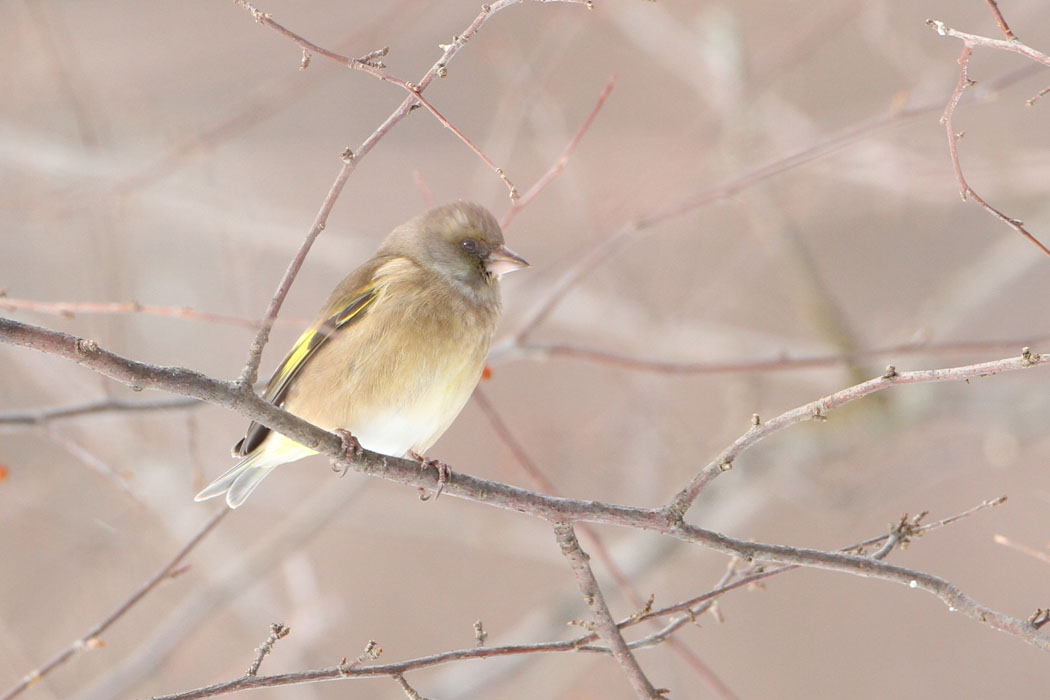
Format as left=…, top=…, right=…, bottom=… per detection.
left=0, top=0, right=1050, bottom=700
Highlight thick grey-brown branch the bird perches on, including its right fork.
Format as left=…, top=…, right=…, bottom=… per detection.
left=0, top=319, right=1050, bottom=697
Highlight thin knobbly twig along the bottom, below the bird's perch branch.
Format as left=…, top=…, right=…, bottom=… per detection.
left=135, top=496, right=1006, bottom=700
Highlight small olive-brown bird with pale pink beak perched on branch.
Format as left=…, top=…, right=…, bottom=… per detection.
left=194, top=201, right=528, bottom=508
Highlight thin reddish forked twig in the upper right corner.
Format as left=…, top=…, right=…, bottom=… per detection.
left=926, top=0, right=1050, bottom=255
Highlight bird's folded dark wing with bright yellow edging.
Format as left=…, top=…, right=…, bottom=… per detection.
left=233, top=279, right=378, bottom=457
